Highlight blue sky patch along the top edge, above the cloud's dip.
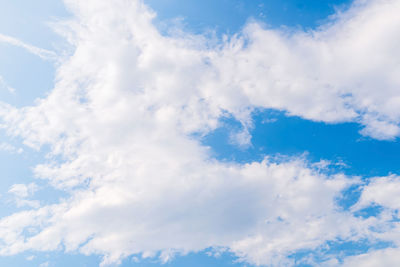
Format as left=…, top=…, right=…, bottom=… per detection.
left=144, top=0, right=351, bottom=35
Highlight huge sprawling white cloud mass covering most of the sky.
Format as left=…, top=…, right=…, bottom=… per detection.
left=0, top=0, right=400, bottom=266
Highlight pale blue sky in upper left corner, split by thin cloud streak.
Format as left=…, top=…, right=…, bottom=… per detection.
left=0, top=0, right=69, bottom=107
